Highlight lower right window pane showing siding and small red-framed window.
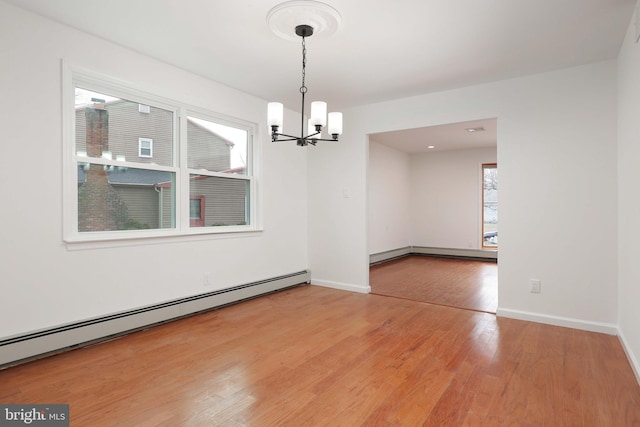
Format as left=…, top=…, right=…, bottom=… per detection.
left=189, top=175, right=249, bottom=227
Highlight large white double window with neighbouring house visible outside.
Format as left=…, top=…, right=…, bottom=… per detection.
left=64, top=65, right=258, bottom=242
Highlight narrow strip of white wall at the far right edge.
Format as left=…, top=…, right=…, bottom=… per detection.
left=618, top=8, right=640, bottom=381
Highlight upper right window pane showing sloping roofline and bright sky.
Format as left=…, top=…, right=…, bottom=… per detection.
left=187, top=117, right=248, bottom=175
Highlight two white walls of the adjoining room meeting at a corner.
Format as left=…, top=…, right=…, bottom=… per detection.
left=368, top=144, right=497, bottom=254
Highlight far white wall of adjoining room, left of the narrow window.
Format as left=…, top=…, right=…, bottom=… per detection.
left=411, top=148, right=497, bottom=249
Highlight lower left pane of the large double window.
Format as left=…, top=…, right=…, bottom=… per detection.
left=78, top=163, right=175, bottom=232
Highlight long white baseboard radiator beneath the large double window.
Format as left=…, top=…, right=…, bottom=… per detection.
left=0, top=270, right=311, bottom=369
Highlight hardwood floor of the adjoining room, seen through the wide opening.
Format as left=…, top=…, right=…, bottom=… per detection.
left=369, top=256, right=498, bottom=313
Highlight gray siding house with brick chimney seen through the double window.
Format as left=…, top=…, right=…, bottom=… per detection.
left=76, top=100, right=249, bottom=231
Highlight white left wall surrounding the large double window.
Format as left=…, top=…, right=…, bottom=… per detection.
left=0, top=2, right=308, bottom=338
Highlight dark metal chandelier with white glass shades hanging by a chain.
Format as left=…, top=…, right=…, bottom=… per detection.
left=267, top=25, right=342, bottom=147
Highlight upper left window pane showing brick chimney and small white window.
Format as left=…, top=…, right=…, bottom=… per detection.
left=75, top=88, right=174, bottom=166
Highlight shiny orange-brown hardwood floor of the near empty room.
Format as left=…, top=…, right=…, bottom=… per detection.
left=0, top=286, right=640, bottom=427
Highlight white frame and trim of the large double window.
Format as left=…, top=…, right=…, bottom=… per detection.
left=62, top=61, right=262, bottom=249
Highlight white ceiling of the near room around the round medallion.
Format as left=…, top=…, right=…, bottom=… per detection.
left=4, top=0, right=635, bottom=154
